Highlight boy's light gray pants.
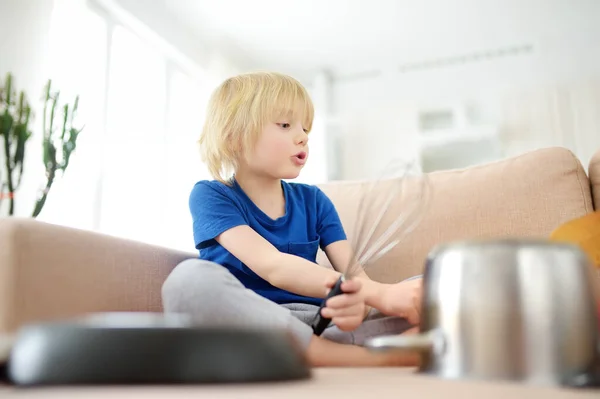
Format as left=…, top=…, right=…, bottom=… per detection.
left=162, top=259, right=419, bottom=348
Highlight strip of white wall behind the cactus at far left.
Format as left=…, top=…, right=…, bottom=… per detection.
left=0, top=0, right=53, bottom=216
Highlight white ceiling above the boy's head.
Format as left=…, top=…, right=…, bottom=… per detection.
left=165, top=0, right=600, bottom=82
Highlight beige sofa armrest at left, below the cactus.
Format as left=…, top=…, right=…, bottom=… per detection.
left=0, top=218, right=196, bottom=333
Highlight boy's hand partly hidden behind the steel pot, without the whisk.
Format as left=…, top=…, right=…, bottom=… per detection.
left=379, top=278, right=423, bottom=325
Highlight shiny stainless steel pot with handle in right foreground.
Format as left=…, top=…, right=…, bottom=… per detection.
left=366, top=240, right=600, bottom=385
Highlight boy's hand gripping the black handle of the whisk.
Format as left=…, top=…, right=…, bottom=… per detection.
left=321, top=280, right=366, bottom=331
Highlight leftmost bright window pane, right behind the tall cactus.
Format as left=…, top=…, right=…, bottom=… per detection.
left=38, top=0, right=108, bottom=229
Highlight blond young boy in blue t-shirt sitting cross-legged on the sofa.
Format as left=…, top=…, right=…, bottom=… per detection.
left=162, top=73, right=421, bottom=366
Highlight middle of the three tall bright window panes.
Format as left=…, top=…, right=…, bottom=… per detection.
left=98, top=26, right=166, bottom=242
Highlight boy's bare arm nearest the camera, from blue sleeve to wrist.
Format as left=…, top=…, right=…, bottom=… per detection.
left=216, top=225, right=340, bottom=298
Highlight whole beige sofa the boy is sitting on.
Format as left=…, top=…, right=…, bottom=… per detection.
left=0, top=148, right=600, bottom=397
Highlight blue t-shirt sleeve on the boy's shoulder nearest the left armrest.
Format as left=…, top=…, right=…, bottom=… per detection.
left=189, top=182, right=247, bottom=249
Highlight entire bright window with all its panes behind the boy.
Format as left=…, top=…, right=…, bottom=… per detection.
left=39, top=0, right=213, bottom=251
